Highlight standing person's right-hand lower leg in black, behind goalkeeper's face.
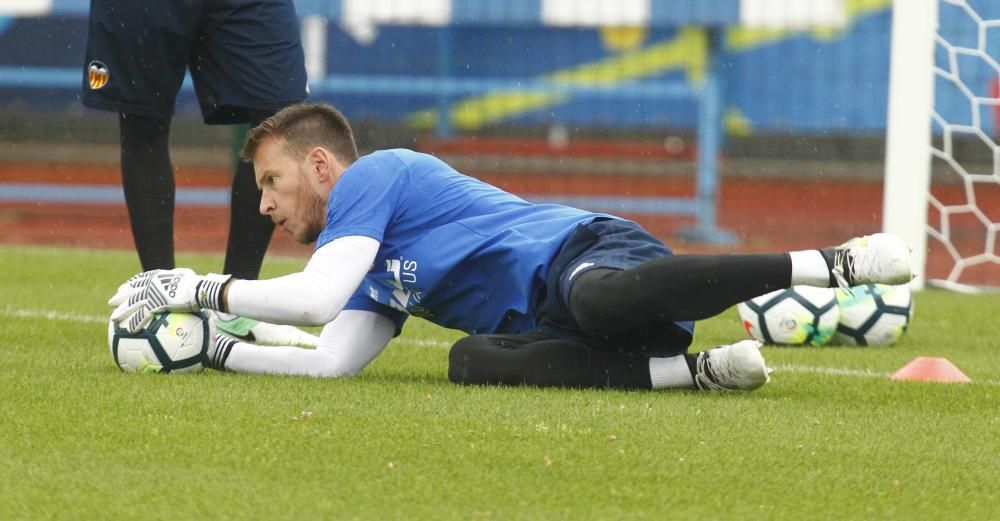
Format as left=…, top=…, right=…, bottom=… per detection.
left=223, top=112, right=274, bottom=280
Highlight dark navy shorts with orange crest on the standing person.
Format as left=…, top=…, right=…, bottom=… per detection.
left=82, top=0, right=307, bottom=124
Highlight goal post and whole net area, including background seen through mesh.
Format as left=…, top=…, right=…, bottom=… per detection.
left=884, top=0, right=1000, bottom=291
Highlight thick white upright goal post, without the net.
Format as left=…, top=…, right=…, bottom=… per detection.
left=882, top=0, right=939, bottom=289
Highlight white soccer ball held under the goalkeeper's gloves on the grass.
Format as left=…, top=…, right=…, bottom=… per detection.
left=108, top=312, right=212, bottom=373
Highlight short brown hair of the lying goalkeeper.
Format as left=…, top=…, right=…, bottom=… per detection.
left=240, top=103, right=358, bottom=165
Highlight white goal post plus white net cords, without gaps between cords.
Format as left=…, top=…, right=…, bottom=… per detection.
left=882, top=0, right=1000, bottom=293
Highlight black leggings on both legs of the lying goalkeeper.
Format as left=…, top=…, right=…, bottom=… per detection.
left=448, top=253, right=791, bottom=389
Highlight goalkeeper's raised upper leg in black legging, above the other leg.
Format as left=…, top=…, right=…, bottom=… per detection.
left=569, top=253, right=792, bottom=334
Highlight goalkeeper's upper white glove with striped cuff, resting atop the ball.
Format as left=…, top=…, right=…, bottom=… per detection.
left=108, top=268, right=232, bottom=333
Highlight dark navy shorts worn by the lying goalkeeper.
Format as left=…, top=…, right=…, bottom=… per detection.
left=536, top=219, right=694, bottom=355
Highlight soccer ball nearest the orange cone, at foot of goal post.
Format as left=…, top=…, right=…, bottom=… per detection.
left=831, top=284, right=913, bottom=346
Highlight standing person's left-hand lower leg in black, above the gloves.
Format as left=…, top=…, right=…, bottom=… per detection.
left=118, top=114, right=176, bottom=271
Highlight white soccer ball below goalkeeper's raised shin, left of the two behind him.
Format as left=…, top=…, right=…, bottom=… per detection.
left=736, top=286, right=840, bottom=346
